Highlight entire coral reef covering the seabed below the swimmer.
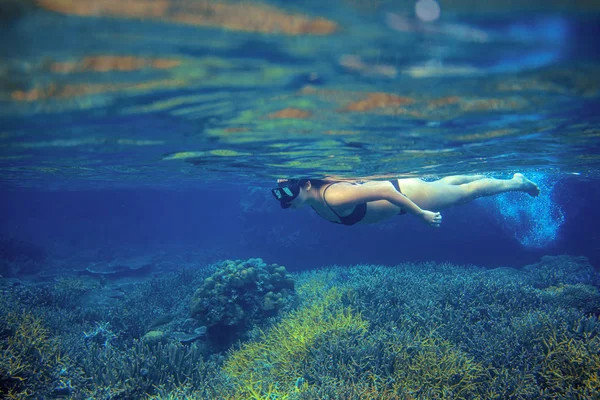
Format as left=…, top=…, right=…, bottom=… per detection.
left=0, top=256, right=600, bottom=400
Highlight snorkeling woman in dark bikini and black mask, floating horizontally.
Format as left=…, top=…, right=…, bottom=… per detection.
left=271, top=174, right=540, bottom=228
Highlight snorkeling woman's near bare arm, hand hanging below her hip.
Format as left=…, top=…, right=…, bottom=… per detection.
left=327, top=182, right=441, bottom=226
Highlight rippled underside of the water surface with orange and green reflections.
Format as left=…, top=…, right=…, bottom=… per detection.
left=0, top=0, right=600, bottom=188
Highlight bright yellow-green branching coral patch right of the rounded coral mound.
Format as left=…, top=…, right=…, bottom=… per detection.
left=223, top=288, right=368, bottom=399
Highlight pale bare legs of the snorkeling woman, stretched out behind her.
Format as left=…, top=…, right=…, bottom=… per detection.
left=399, top=174, right=540, bottom=211
